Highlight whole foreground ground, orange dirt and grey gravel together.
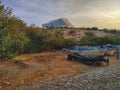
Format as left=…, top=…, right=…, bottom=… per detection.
left=0, top=52, right=120, bottom=90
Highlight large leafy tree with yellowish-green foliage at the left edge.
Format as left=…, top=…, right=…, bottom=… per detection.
left=0, top=3, right=29, bottom=58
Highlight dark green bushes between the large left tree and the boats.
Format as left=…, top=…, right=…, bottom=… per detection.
left=25, top=27, right=76, bottom=53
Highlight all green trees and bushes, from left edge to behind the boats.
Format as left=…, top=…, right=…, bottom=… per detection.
left=0, top=3, right=120, bottom=59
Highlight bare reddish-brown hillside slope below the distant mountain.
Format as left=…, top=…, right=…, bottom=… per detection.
left=48, top=28, right=115, bottom=40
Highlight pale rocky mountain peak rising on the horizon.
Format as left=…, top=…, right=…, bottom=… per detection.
left=42, top=18, right=74, bottom=28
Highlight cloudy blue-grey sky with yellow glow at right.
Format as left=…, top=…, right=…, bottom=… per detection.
left=2, top=0, right=120, bottom=29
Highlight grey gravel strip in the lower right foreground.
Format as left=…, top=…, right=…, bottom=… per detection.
left=17, top=65, right=120, bottom=90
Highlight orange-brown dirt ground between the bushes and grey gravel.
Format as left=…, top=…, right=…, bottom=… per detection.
left=0, top=52, right=120, bottom=90
